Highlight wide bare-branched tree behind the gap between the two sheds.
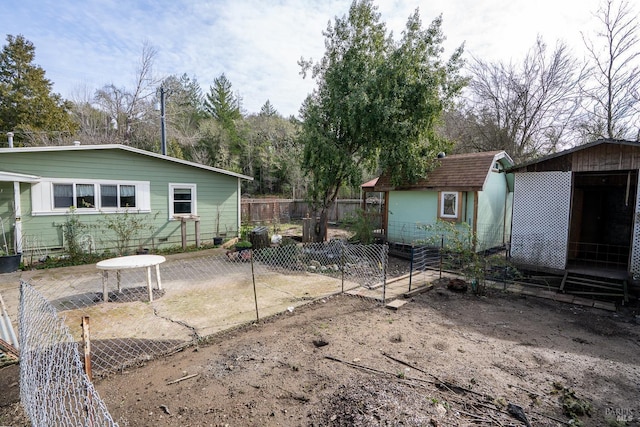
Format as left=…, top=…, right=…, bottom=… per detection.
left=448, top=37, right=583, bottom=161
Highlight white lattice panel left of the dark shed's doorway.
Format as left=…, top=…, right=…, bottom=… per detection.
left=511, top=172, right=571, bottom=270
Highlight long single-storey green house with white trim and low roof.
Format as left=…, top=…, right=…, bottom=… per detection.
left=0, top=143, right=252, bottom=261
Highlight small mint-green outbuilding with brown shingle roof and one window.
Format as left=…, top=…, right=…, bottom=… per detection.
left=362, top=151, right=513, bottom=251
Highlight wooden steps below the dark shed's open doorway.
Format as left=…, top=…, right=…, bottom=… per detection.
left=560, top=270, right=629, bottom=304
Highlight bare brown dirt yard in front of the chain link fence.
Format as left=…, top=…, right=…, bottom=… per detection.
left=0, top=272, right=640, bottom=427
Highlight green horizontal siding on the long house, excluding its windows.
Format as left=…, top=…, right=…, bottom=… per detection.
left=0, top=149, right=239, bottom=251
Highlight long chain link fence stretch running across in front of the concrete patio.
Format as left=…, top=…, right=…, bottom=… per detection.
left=11, top=241, right=387, bottom=382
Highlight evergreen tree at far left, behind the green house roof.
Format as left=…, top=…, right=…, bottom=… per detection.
left=0, top=35, right=77, bottom=143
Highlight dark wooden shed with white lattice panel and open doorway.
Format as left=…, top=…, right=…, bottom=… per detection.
left=508, top=139, right=640, bottom=300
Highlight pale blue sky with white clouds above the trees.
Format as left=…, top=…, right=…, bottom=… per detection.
left=5, top=0, right=600, bottom=117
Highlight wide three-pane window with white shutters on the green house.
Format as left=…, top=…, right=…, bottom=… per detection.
left=31, top=179, right=151, bottom=215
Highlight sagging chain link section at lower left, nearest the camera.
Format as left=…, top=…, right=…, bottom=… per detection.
left=19, top=282, right=117, bottom=426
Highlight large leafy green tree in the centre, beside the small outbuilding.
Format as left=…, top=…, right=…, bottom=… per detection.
left=301, top=0, right=465, bottom=239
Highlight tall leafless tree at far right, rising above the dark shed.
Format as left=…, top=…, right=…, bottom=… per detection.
left=582, top=0, right=640, bottom=140
